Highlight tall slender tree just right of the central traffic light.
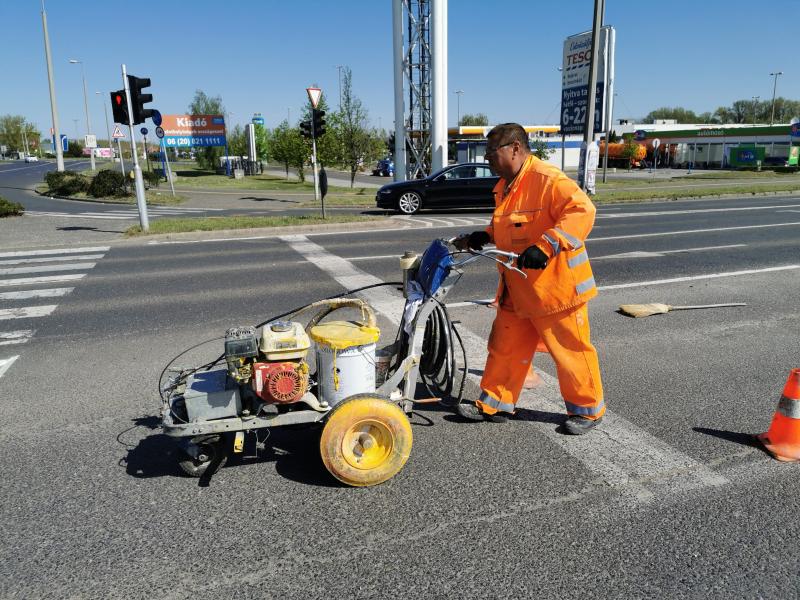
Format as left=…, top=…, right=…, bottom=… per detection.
left=337, top=67, right=384, bottom=188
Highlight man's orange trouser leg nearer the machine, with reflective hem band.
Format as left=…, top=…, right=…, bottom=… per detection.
left=476, top=308, right=539, bottom=415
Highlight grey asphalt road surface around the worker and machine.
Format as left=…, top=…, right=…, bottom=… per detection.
left=0, top=184, right=800, bottom=598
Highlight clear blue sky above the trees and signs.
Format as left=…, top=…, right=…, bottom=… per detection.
left=0, top=0, right=800, bottom=137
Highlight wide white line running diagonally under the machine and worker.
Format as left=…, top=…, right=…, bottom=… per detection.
left=280, top=235, right=728, bottom=502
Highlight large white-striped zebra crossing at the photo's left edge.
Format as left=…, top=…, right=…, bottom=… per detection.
left=0, top=246, right=110, bottom=377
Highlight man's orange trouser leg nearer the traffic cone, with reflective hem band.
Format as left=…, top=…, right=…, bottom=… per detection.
left=534, top=304, right=606, bottom=419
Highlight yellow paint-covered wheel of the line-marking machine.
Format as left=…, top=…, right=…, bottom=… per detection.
left=319, top=394, right=413, bottom=486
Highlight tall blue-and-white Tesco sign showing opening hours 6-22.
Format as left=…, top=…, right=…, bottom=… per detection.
left=561, top=27, right=616, bottom=134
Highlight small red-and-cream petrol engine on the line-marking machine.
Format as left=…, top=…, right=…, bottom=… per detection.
left=225, top=321, right=311, bottom=404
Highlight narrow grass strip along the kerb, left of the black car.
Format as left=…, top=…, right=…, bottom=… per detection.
left=125, top=215, right=384, bottom=236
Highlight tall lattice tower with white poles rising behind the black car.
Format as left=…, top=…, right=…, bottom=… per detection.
left=392, top=0, right=447, bottom=181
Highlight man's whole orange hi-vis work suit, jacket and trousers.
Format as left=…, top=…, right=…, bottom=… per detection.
left=476, top=155, right=605, bottom=419
